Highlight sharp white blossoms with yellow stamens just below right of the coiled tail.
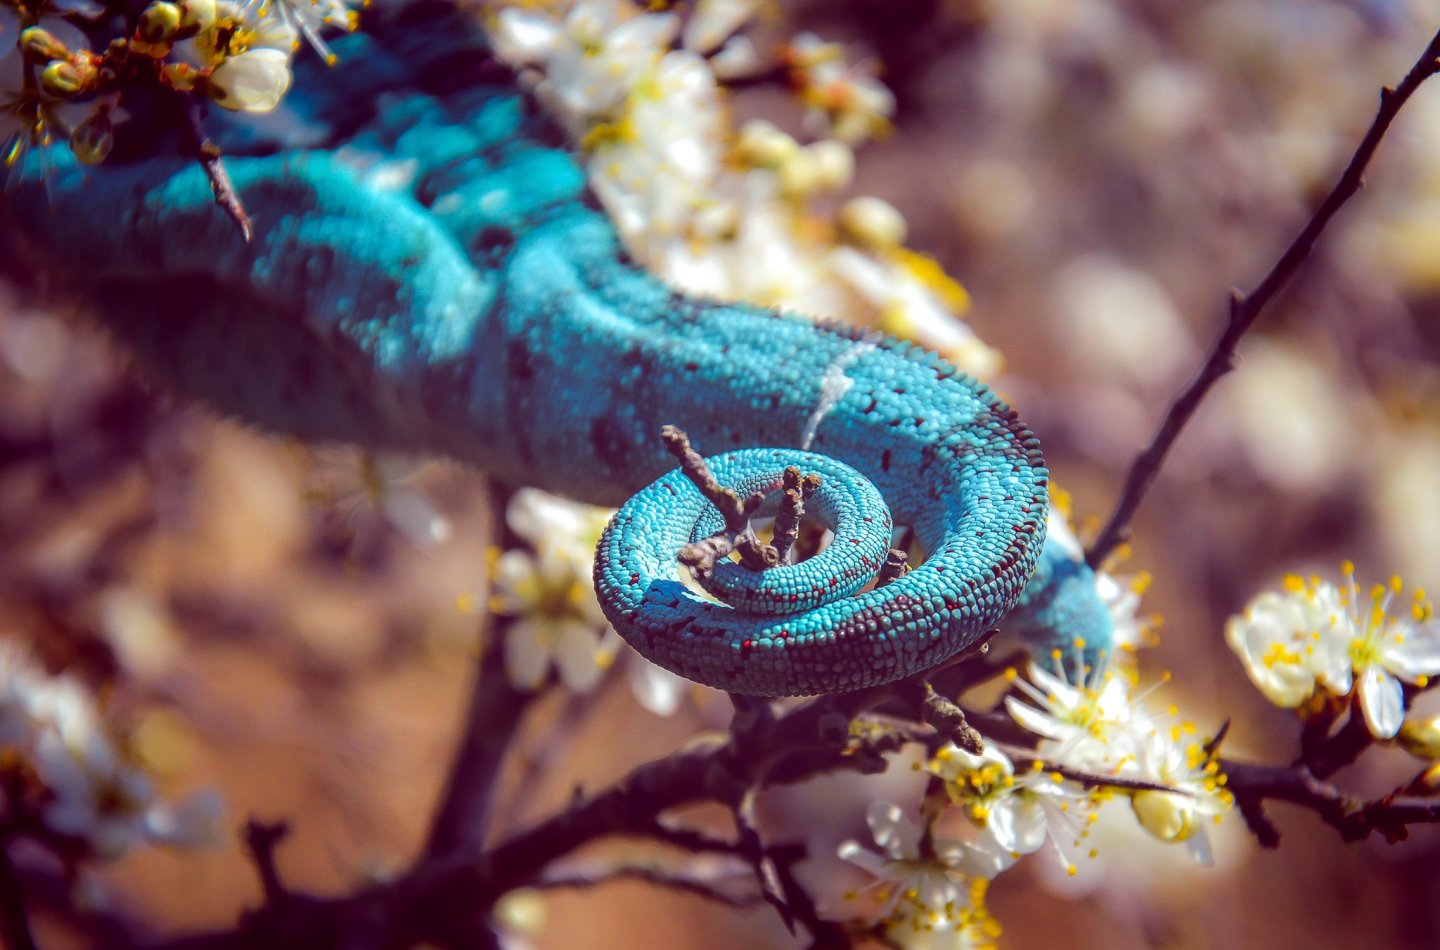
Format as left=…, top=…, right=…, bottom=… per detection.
left=840, top=643, right=1233, bottom=947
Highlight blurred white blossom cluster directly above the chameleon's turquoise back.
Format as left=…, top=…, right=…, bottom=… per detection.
left=490, top=0, right=999, bottom=376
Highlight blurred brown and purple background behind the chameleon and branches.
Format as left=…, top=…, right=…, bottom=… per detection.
left=0, top=0, right=1440, bottom=947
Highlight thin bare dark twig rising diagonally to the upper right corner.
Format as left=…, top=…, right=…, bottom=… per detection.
left=1086, top=25, right=1440, bottom=567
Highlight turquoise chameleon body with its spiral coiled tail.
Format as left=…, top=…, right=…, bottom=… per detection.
left=7, top=4, right=1109, bottom=695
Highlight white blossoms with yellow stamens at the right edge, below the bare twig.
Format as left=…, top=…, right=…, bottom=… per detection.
left=1225, top=561, right=1440, bottom=738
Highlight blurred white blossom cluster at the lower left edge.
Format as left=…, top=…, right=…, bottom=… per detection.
left=0, top=641, right=222, bottom=859
